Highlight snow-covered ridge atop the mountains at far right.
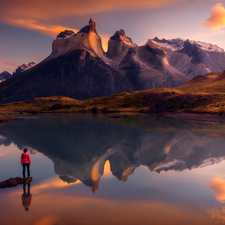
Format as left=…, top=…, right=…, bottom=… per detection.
left=151, top=38, right=224, bottom=53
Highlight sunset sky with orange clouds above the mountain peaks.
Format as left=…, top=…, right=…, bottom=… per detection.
left=0, top=0, right=225, bottom=73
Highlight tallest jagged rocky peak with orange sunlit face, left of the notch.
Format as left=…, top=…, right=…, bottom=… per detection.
left=49, top=19, right=105, bottom=61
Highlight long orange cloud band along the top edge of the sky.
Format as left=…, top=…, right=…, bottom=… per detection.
left=0, top=0, right=184, bottom=20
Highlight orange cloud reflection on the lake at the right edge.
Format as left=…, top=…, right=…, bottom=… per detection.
left=204, top=177, right=225, bottom=203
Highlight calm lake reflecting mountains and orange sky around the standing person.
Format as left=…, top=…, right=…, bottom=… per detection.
left=0, top=114, right=225, bottom=225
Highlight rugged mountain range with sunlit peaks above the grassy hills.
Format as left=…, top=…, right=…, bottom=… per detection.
left=0, top=19, right=225, bottom=103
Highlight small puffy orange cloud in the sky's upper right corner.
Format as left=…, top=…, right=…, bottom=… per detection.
left=202, top=3, right=225, bottom=30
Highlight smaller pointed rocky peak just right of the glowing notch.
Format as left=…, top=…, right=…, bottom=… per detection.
left=106, top=29, right=137, bottom=59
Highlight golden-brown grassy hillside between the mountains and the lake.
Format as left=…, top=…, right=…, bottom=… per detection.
left=0, top=72, right=225, bottom=115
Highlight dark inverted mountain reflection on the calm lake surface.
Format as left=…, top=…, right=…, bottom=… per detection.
left=0, top=115, right=225, bottom=192
